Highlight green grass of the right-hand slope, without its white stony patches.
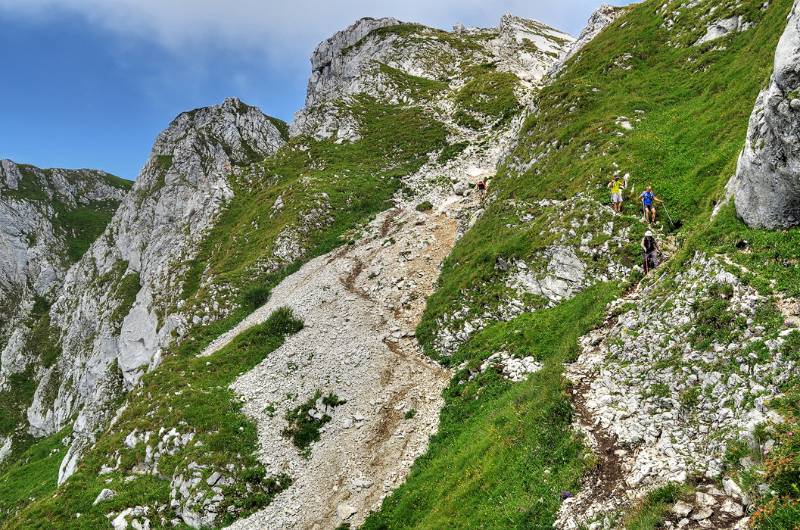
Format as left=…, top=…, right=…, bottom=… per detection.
left=366, top=0, right=800, bottom=528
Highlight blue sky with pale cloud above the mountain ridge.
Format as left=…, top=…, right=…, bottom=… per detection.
left=0, top=0, right=620, bottom=179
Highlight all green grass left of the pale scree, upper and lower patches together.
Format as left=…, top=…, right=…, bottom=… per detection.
left=0, top=65, right=447, bottom=528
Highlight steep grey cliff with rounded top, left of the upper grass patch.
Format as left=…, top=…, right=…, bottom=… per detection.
left=20, top=99, right=283, bottom=481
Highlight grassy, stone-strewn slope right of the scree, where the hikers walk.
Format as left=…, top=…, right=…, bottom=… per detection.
left=365, top=2, right=797, bottom=528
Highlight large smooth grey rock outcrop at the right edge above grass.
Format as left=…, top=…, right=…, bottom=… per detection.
left=731, top=3, right=800, bottom=228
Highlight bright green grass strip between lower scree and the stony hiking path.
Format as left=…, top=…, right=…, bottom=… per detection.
left=362, top=284, right=619, bottom=530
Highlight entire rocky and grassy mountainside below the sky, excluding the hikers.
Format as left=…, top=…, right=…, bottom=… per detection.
left=0, top=0, right=800, bottom=530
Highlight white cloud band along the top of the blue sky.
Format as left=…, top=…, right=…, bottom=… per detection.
left=0, top=0, right=616, bottom=64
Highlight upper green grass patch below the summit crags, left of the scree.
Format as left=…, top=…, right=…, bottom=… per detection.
left=184, top=93, right=446, bottom=300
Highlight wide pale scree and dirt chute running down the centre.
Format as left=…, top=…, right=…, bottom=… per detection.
left=208, top=203, right=459, bottom=529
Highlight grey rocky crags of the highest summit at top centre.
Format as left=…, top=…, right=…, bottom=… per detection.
left=291, top=15, right=573, bottom=140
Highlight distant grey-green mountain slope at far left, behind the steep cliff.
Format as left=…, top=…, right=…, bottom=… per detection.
left=0, top=160, right=131, bottom=461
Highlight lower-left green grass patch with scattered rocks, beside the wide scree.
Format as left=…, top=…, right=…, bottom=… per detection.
left=0, top=308, right=303, bottom=529
